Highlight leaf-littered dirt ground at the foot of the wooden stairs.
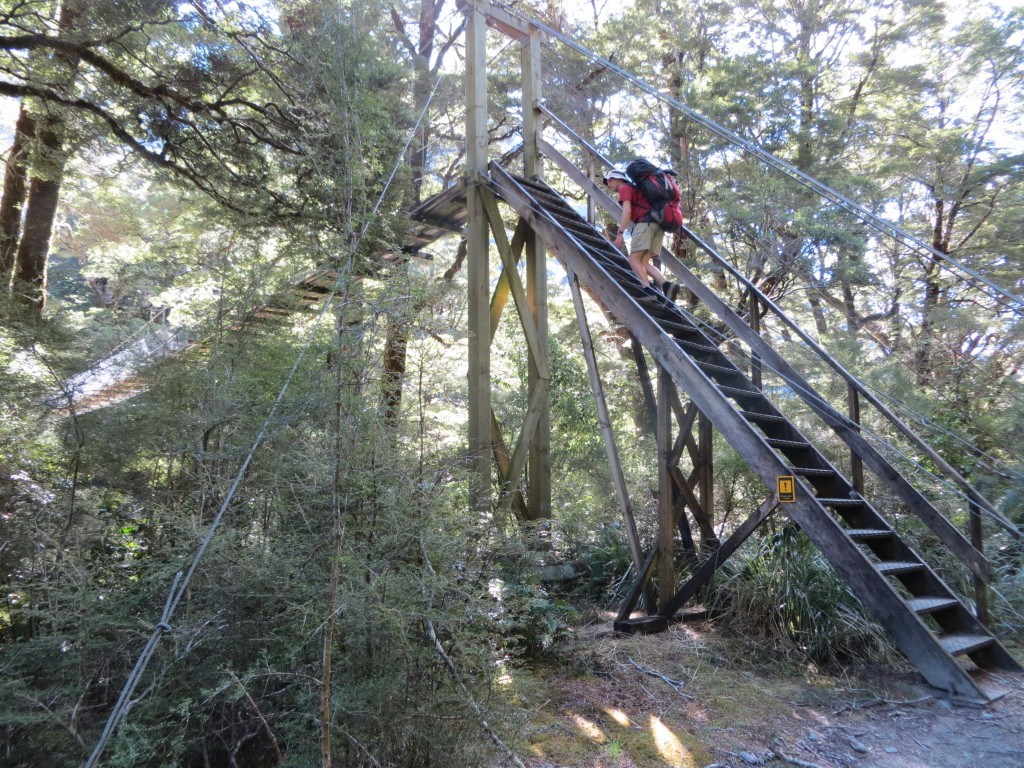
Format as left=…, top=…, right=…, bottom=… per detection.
left=507, top=617, right=1024, bottom=768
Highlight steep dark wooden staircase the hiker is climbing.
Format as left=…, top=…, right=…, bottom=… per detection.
left=490, top=164, right=1021, bottom=700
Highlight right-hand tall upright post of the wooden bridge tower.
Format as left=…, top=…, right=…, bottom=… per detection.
left=520, top=30, right=551, bottom=519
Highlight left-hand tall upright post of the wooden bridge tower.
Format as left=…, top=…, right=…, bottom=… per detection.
left=466, top=2, right=493, bottom=512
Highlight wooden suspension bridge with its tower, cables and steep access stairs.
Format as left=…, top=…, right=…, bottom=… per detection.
left=72, top=6, right=1024, bottom=765
